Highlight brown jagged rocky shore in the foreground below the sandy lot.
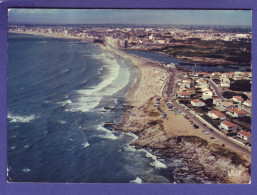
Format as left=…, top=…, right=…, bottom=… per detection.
left=114, top=104, right=251, bottom=184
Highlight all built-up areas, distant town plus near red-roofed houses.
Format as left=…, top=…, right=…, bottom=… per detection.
left=9, top=25, right=252, bottom=151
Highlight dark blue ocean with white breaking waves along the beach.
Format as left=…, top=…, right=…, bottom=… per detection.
left=8, top=34, right=210, bottom=183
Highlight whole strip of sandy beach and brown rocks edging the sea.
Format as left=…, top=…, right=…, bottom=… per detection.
left=9, top=32, right=249, bottom=183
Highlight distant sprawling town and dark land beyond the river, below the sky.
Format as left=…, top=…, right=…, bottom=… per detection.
left=9, top=25, right=252, bottom=67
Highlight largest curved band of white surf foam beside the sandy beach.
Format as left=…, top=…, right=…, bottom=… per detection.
left=63, top=53, right=129, bottom=112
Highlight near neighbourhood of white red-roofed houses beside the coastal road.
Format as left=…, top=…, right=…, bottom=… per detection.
left=155, top=67, right=252, bottom=151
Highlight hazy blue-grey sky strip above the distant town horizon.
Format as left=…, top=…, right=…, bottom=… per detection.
left=8, top=8, right=252, bottom=25
